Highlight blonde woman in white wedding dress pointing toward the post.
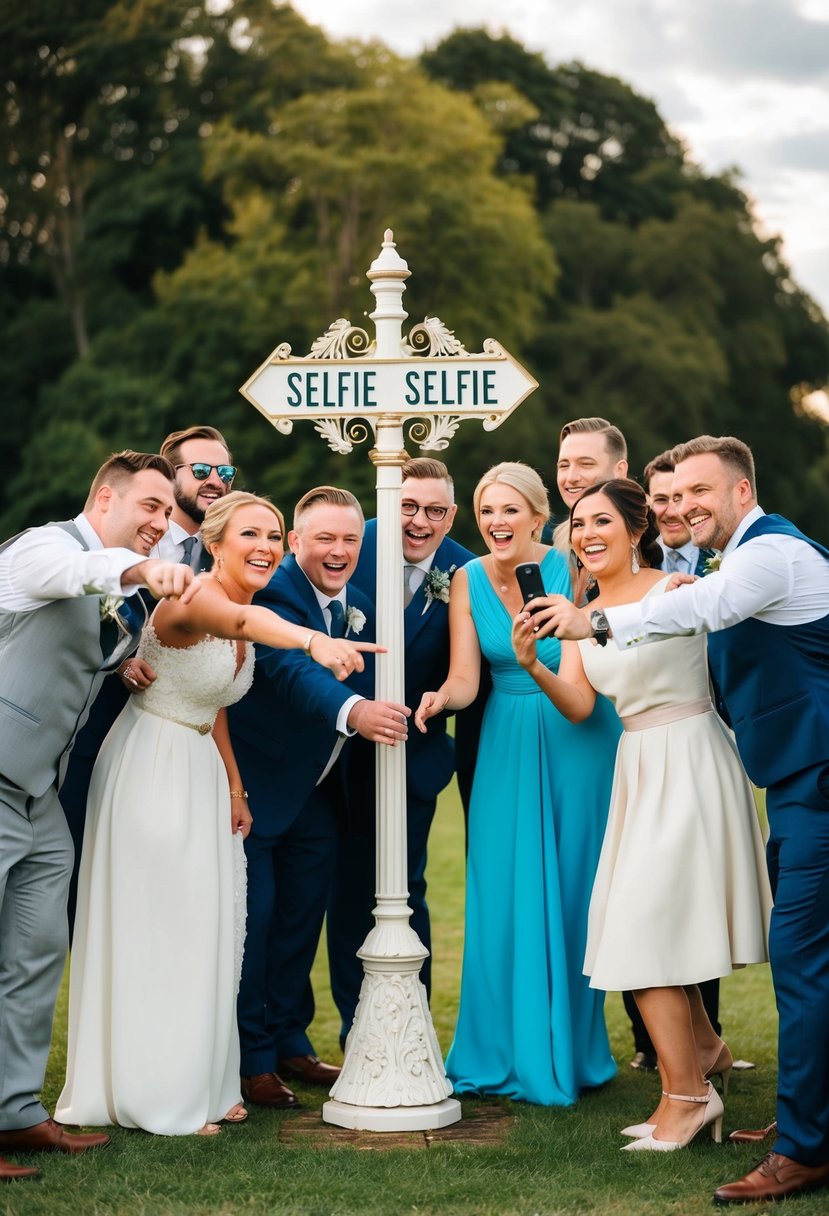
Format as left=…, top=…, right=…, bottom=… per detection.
left=56, top=491, right=377, bottom=1136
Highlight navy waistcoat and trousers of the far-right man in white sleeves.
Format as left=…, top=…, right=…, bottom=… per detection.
left=709, top=514, right=829, bottom=1165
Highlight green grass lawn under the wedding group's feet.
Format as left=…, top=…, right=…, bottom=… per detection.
left=6, top=788, right=807, bottom=1216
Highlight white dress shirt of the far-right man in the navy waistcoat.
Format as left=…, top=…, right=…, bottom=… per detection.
left=605, top=507, right=829, bottom=649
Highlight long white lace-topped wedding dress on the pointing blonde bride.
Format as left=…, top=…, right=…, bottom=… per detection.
left=55, top=624, right=253, bottom=1136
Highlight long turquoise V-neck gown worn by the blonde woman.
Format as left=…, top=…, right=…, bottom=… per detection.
left=446, top=550, right=621, bottom=1107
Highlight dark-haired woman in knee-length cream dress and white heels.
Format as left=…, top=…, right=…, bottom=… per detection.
left=513, top=479, right=771, bottom=1152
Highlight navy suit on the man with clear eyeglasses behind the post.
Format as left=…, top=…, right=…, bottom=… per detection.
left=328, top=519, right=480, bottom=1035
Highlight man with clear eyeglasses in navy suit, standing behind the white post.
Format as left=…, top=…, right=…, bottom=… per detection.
left=328, top=457, right=478, bottom=1038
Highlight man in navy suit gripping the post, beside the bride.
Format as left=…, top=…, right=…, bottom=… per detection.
left=229, top=486, right=408, bottom=1108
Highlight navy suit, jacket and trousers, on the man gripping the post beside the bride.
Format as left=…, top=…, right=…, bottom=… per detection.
left=229, top=556, right=373, bottom=1076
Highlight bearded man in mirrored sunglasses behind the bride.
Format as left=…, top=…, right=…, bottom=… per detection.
left=60, top=427, right=236, bottom=941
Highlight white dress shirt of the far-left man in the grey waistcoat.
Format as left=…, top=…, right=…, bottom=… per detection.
left=0, top=514, right=146, bottom=612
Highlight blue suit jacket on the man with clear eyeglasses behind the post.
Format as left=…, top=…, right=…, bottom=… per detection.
left=351, top=519, right=475, bottom=801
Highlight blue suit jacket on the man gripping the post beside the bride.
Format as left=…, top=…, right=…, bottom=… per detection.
left=227, top=556, right=374, bottom=835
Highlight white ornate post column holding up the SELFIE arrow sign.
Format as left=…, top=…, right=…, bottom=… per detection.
left=322, top=229, right=461, bottom=1131
